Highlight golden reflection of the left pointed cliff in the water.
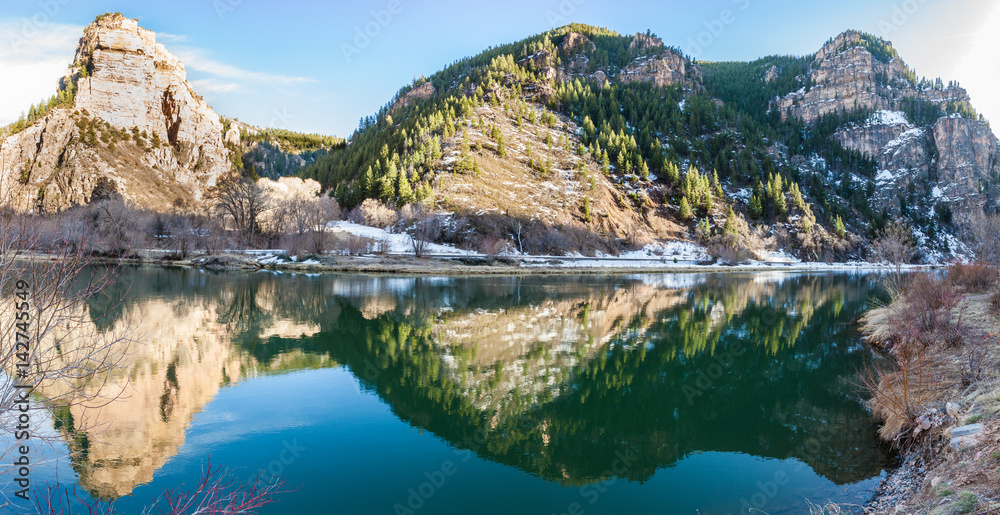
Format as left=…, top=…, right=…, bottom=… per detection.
left=49, top=270, right=328, bottom=497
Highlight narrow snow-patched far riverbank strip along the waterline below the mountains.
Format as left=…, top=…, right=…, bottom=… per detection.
left=22, top=250, right=936, bottom=276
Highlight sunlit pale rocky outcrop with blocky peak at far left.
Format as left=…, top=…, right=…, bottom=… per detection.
left=0, top=14, right=231, bottom=211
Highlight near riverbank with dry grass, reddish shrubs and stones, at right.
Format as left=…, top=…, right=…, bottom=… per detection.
left=862, top=267, right=1000, bottom=514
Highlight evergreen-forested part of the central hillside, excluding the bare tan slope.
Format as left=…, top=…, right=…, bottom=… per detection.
left=301, top=25, right=995, bottom=257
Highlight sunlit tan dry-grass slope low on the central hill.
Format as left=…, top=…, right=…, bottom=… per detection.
left=433, top=106, right=686, bottom=254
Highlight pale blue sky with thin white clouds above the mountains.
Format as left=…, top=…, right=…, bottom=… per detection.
left=0, top=0, right=1000, bottom=136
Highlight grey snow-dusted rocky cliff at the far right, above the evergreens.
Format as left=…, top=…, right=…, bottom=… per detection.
left=772, top=31, right=1000, bottom=235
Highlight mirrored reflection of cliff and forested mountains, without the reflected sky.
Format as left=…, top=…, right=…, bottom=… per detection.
left=45, top=269, right=885, bottom=497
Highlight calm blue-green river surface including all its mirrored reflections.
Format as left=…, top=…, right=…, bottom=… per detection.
left=15, top=268, right=892, bottom=515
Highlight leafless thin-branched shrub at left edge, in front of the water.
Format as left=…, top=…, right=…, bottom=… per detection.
left=0, top=215, right=132, bottom=492
